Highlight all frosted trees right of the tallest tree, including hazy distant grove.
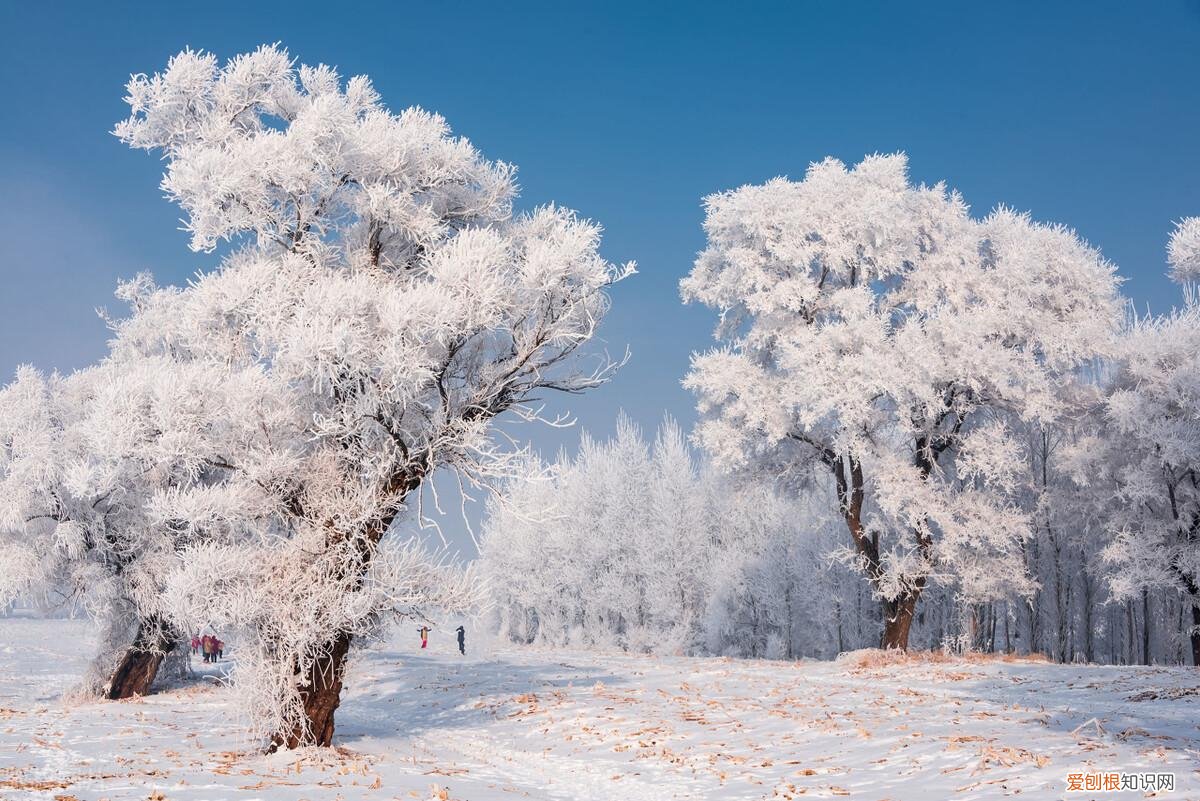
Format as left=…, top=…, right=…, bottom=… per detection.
left=484, top=156, right=1200, bottom=664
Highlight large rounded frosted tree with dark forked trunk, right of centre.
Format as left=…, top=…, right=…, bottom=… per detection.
left=682, top=155, right=1120, bottom=648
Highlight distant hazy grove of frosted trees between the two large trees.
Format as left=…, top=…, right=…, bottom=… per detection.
left=481, top=416, right=854, bottom=658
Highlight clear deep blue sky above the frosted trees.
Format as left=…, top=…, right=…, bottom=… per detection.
left=0, top=0, right=1200, bottom=551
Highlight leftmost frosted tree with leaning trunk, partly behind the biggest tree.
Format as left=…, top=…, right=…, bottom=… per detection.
left=0, top=350, right=269, bottom=698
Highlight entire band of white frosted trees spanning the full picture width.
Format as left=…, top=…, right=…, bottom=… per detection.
left=0, top=47, right=1200, bottom=748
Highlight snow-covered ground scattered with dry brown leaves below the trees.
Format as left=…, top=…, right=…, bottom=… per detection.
left=0, top=619, right=1200, bottom=801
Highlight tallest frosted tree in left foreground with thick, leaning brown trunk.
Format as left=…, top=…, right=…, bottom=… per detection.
left=110, top=47, right=632, bottom=747
